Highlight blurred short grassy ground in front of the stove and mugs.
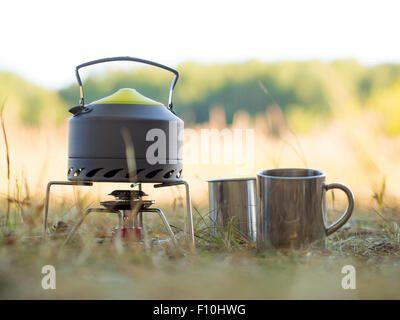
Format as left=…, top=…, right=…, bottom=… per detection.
left=0, top=208, right=400, bottom=299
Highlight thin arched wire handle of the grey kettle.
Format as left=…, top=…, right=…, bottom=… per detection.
left=75, top=56, right=179, bottom=111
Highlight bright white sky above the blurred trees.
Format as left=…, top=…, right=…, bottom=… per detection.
left=0, top=0, right=400, bottom=88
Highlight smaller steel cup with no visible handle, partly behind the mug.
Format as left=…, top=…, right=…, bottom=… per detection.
left=207, top=178, right=257, bottom=242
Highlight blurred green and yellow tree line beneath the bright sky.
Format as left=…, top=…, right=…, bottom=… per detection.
left=0, top=60, right=400, bottom=134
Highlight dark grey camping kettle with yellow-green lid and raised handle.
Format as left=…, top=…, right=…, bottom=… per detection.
left=68, top=56, right=184, bottom=183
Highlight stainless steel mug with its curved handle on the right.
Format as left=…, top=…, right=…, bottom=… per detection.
left=257, top=169, right=354, bottom=250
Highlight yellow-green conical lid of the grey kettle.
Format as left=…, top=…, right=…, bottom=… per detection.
left=91, top=88, right=163, bottom=106
